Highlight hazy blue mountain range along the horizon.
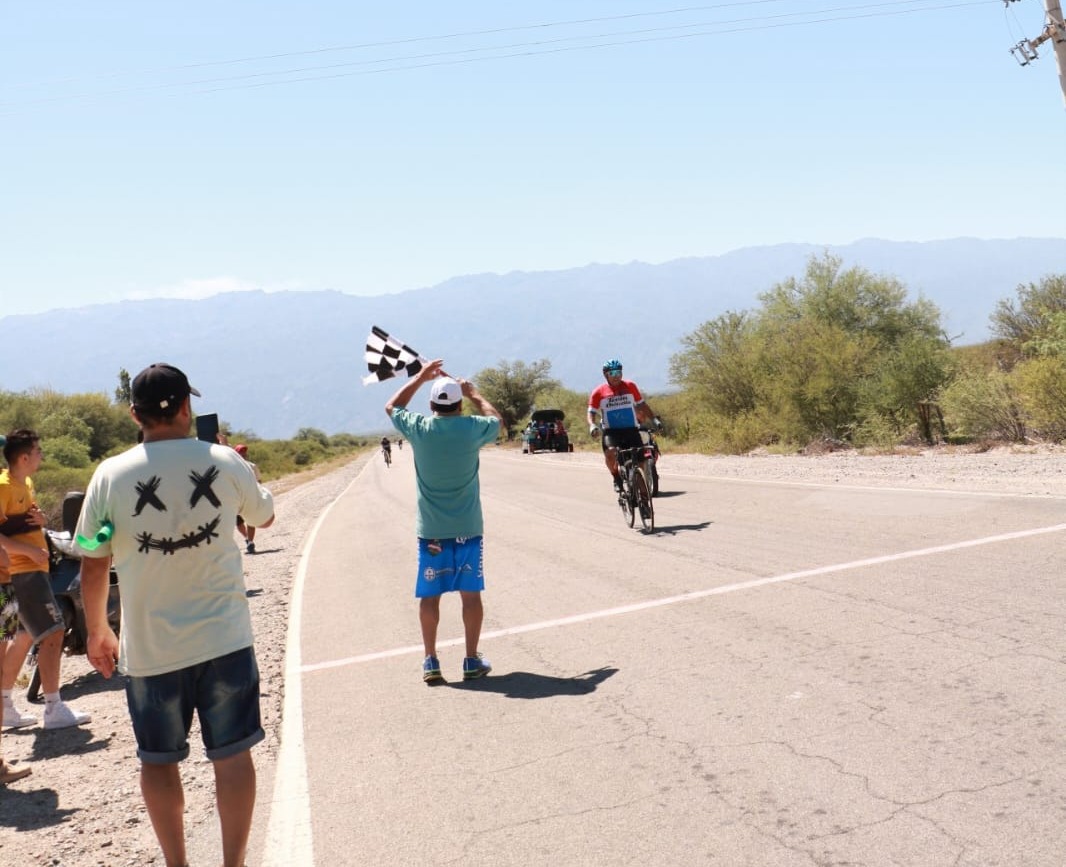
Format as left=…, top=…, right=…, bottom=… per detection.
left=0, top=238, right=1066, bottom=438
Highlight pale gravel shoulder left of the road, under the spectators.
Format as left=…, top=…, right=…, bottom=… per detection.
left=0, top=453, right=372, bottom=867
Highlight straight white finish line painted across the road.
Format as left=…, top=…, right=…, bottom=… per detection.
left=298, top=524, right=1066, bottom=679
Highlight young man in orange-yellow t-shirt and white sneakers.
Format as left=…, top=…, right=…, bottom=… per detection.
left=0, top=428, right=92, bottom=728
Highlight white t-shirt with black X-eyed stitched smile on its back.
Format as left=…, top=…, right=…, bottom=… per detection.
left=77, top=439, right=274, bottom=677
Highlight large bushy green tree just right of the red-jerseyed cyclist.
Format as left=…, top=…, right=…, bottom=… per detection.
left=671, top=254, right=949, bottom=449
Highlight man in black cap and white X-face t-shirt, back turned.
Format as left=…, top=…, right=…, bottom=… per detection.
left=77, top=364, right=274, bottom=867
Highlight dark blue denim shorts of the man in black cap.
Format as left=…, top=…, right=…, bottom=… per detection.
left=126, top=647, right=267, bottom=765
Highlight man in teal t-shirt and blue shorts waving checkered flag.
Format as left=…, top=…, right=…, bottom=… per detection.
left=385, top=358, right=501, bottom=684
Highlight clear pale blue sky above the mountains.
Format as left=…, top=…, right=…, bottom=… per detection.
left=0, top=0, right=1066, bottom=315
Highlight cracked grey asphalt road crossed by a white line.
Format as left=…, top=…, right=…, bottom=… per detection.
left=267, top=449, right=1066, bottom=867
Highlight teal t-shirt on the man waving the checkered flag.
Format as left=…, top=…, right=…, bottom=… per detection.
left=392, top=408, right=500, bottom=539
